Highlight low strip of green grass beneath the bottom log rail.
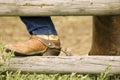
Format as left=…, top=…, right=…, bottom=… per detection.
left=0, top=71, right=120, bottom=80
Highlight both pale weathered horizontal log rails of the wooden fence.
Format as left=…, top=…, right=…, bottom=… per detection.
left=0, top=0, right=120, bottom=74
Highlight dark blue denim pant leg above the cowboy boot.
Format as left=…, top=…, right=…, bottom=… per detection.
left=20, top=16, right=57, bottom=35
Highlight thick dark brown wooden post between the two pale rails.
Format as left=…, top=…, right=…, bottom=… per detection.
left=90, top=16, right=120, bottom=55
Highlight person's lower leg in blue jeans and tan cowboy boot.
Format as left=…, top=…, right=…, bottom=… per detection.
left=5, top=17, right=60, bottom=56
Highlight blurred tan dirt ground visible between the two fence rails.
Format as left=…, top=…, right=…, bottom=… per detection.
left=0, top=16, right=92, bottom=56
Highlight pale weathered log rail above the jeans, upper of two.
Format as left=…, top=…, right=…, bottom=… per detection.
left=0, top=0, right=120, bottom=16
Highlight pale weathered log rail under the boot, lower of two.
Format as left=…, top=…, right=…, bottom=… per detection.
left=0, top=56, right=120, bottom=74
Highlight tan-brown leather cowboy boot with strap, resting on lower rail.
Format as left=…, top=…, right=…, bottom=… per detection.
left=4, top=35, right=61, bottom=56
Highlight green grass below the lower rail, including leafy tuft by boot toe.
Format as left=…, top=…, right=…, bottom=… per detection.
left=0, top=43, right=120, bottom=80
